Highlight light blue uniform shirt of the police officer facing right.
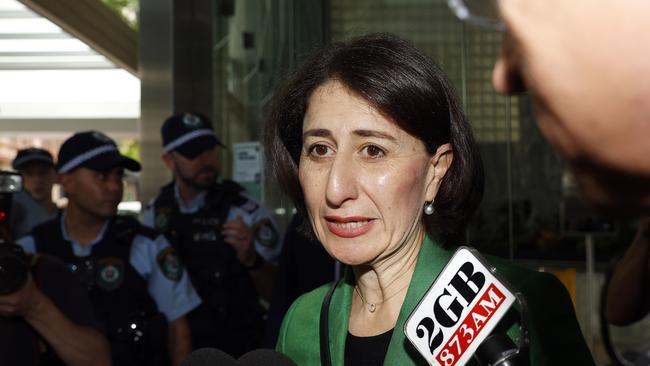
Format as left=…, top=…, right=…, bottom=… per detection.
left=16, top=216, right=201, bottom=322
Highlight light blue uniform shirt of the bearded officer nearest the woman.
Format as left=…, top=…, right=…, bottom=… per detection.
left=142, top=184, right=282, bottom=265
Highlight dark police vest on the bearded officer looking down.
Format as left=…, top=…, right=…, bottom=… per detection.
left=153, top=180, right=263, bottom=356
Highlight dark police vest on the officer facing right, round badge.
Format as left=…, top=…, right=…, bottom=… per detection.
left=32, top=216, right=168, bottom=366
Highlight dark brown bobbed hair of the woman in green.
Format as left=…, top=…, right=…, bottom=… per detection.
left=264, top=33, right=483, bottom=247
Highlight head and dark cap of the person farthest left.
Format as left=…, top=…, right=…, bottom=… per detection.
left=11, top=147, right=57, bottom=215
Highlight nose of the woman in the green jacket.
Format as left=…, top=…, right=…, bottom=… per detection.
left=325, top=155, right=358, bottom=207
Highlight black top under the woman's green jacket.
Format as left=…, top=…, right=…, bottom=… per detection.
left=345, top=329, right=393, bottom=366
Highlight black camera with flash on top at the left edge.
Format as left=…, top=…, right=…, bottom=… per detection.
left=0, top=171, right=29, bottom=295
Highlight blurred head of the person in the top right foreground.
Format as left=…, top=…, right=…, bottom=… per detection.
left=493, top=0, right=650, bottom=217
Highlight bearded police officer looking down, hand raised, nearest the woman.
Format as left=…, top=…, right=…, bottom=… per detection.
left=144, top=113, right=281, bottom=356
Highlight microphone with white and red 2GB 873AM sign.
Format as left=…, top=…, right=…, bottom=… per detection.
left=404, top=247, right=529, bottom=366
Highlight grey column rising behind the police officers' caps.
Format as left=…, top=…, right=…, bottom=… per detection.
left=139, top=0, right=214, bottom=203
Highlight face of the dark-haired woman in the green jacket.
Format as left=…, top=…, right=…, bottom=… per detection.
left=299, top=81, right=451, bottom=265
